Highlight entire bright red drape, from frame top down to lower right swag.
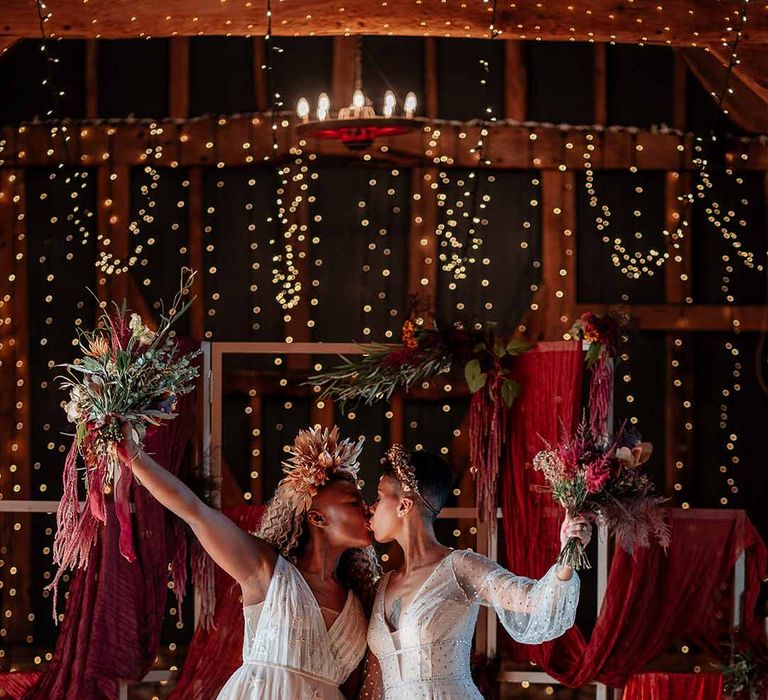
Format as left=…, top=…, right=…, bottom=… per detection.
left=502, top=343, right=766, bottom=687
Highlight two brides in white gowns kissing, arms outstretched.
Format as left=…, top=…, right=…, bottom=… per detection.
left=120, top=424, right=591, bottom=700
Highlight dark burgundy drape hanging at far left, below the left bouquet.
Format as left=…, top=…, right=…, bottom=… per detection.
left=24, top=388, right=195, bottom=700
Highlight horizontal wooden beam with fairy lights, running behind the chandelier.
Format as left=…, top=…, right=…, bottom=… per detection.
left=6, top=117, right=768, bottom=170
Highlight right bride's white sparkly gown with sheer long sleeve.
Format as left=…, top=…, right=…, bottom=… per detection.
left=361, top=550, right=579, bottom=700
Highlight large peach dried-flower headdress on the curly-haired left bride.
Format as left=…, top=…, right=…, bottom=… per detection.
left=277, top=425, right=365, bottom=513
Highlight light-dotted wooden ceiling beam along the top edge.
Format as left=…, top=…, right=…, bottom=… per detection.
left=0, top=0, right=768, bottom=46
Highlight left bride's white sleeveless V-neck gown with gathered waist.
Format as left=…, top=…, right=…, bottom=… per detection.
left=218, top=556, right=368, bottom=700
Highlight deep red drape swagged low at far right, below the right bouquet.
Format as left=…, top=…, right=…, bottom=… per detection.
left=536, top=510, right=766, bottom=686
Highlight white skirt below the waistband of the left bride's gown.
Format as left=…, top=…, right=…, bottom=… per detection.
left=218, top=663, right=344, bottom=700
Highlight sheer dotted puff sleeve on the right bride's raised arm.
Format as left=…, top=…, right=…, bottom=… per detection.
left=453, top=550, right=579, bottom=644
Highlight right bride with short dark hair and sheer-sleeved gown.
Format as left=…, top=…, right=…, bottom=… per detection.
left=361, top=445, right=591, bottom=700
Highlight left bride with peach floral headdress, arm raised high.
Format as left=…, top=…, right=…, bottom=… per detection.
left=121, top=427, right=378, bottom=700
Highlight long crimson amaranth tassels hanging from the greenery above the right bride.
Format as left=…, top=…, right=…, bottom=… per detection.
left=469, top=369, right=507, bottom=525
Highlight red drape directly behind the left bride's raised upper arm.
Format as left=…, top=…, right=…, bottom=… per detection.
left=169, top=506, right=264, bottom=700
